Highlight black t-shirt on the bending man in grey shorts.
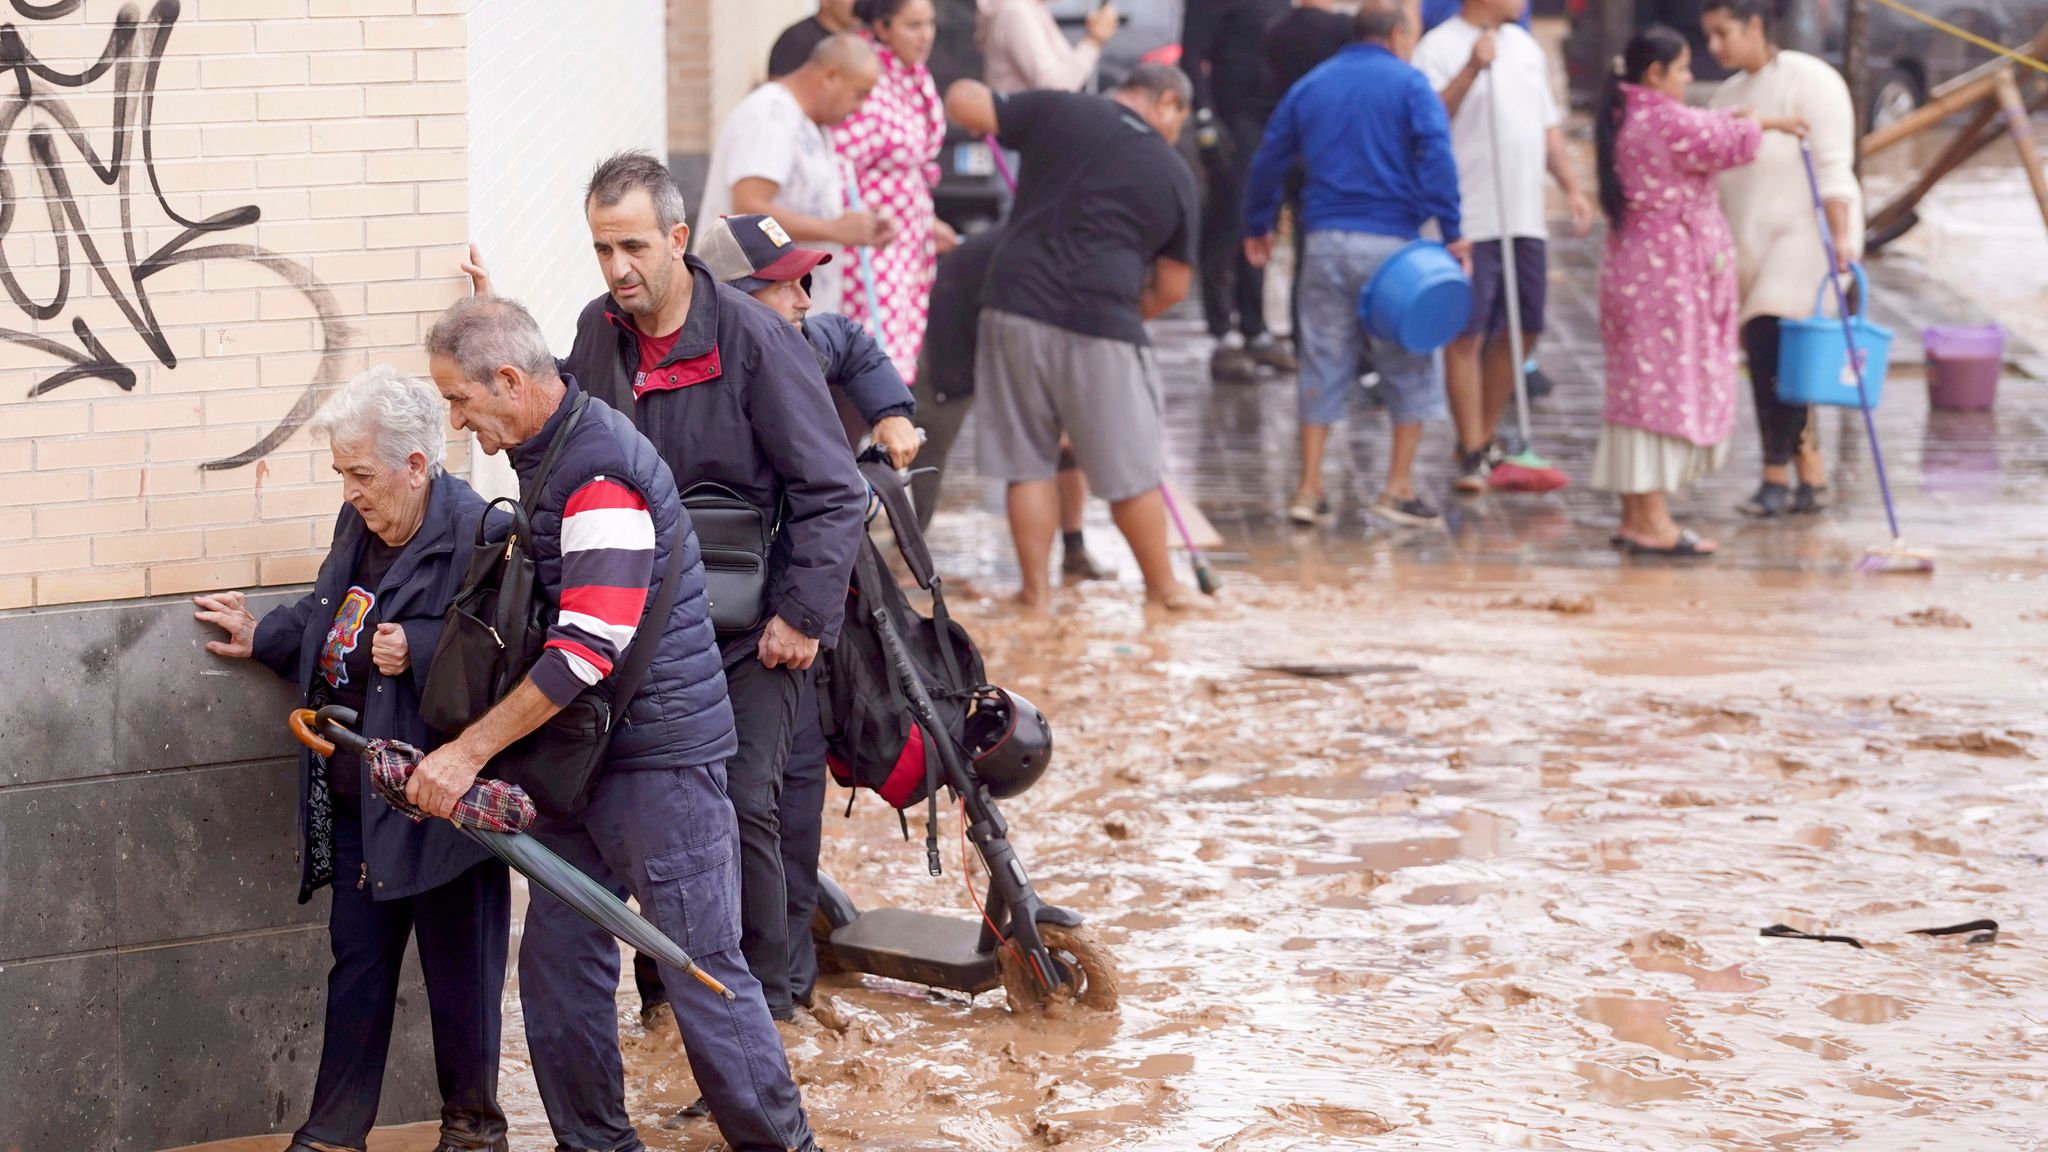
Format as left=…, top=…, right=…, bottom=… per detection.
left=981, top=92, right=1200, bottom=344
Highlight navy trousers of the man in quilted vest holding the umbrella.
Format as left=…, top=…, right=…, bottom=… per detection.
left=518, top=765, right=813, bottom=1152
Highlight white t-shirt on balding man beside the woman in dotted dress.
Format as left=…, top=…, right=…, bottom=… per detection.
left=692, top=80, right=846, bottom=312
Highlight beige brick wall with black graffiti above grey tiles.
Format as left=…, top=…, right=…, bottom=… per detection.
left=0, top=0, right=471, bottom=607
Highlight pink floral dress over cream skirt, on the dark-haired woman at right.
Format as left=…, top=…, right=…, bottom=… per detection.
left=1599, top=84, right=1763, bottom=447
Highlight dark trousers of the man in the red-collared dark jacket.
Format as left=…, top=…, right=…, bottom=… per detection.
left=633, top=656, right=817, bottom=1021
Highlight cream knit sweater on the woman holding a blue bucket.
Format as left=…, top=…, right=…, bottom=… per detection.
left=1710, top=51, right=1864, bottom=322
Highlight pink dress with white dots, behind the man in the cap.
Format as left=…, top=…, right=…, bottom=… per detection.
left=831, top=43, right=946, bottom=383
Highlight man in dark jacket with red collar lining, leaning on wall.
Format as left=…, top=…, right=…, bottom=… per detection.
left=485, top=152, right=866, bottom=1019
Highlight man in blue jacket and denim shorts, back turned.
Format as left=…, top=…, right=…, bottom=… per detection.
left=1245, top=0, right=1470, bottom=527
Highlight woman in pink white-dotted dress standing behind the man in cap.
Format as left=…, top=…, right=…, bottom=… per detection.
left=831, top=0, right=958, bottom=383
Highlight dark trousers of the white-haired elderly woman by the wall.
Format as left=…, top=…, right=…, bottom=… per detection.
left=297, top=801, right=512, bottom=1148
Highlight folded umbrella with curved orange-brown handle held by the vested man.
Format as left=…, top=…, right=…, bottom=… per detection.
left=291, top=707, right=733, bottom=1000
